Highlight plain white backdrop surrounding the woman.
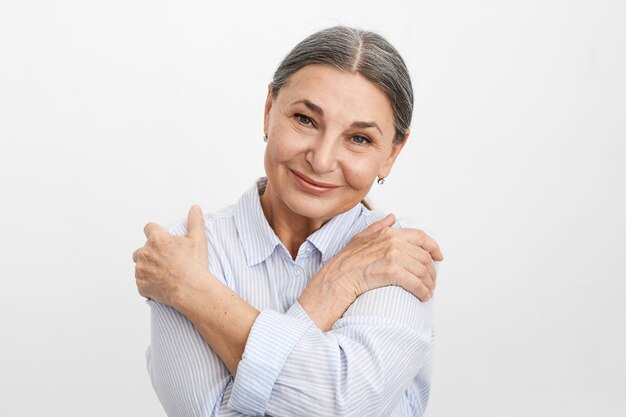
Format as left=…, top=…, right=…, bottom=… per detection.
left=0, top=0, right=626, bottom=417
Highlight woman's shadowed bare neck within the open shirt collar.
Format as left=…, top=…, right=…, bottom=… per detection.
left=261, top=183, right=325, bottom=259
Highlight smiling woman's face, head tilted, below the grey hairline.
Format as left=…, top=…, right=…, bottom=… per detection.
left=265, top=65, right=406, bottom=221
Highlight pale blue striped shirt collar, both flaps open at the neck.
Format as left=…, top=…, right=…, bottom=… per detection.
left=234, top=178, right=363, bottom=266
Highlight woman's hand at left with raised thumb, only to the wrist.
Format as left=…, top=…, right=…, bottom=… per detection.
left=133, top=206, right=210, bottom=308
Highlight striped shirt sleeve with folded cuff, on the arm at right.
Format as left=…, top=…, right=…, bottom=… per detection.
left=228, top=287, right=433, bottom=416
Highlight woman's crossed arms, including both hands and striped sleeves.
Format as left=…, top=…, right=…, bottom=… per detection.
left=134, top=209, right=441, bottom=415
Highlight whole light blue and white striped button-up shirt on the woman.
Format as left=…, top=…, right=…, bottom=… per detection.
left=146, top=180, right=433, bottom=417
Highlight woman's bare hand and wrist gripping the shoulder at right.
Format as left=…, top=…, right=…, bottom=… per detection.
left=299, top=214, right=443, bottom=331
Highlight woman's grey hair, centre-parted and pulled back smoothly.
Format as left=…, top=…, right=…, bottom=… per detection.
left=272, top=26, right=413, bottom=143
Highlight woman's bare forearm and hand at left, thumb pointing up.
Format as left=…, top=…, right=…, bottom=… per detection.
left=133, top=206, right=259, bottom=375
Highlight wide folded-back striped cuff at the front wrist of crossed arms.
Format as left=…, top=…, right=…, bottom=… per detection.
left=228, top=303, right=314, bottom=415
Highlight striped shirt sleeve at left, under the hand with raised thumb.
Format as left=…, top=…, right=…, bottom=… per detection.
left=146, top=218, right=232, bottom=417
